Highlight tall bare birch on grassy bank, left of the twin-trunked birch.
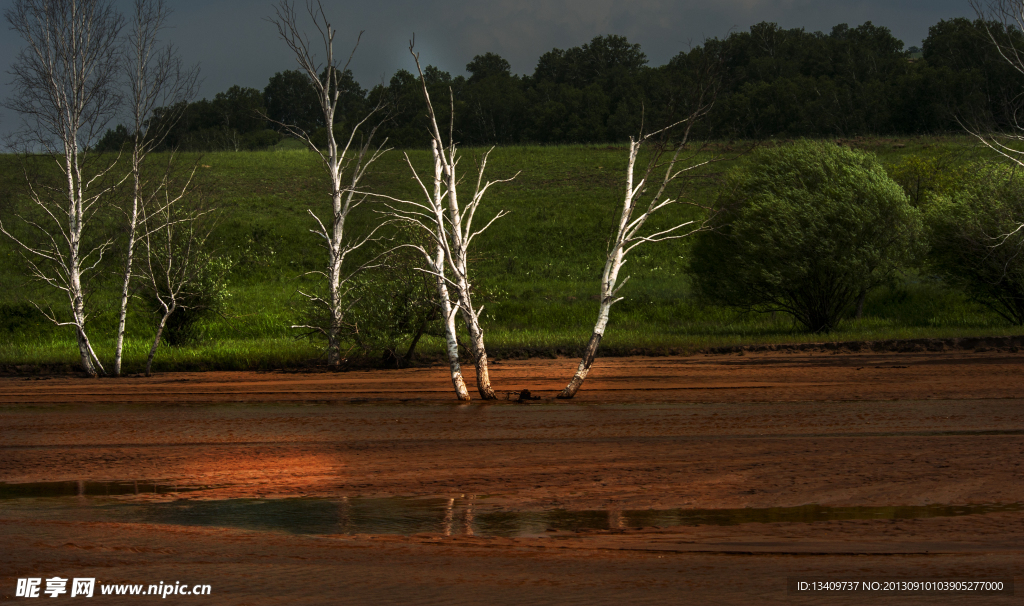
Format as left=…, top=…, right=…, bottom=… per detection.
left=268, top=0, right=386, bottom=366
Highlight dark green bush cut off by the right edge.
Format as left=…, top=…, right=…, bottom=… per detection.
left=926, top=167, right=1024, bottom=326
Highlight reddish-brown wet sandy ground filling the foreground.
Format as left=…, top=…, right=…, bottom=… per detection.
left=0, top=352, right=1024, bottom=604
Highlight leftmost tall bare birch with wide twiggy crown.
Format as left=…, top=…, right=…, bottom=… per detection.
left=0, top=0, right=123, bottom=377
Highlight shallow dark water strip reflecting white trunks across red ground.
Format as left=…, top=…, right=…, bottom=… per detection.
left=0, top=481, right=1024, bottom=537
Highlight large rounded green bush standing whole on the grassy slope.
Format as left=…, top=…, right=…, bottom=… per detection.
left=690, top=141, right=922, bottom=333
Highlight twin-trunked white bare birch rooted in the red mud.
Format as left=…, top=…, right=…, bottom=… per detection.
left=376, top=42, right=518, bottom=400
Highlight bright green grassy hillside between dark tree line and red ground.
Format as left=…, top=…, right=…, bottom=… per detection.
left=0, top=137, right=1016, bottom=372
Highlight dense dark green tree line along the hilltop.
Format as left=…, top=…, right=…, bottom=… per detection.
left=94, top=18, right=1024, bottom=149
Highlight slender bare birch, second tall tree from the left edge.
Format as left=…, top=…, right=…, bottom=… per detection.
left=114, top=0, right=199, bottom=377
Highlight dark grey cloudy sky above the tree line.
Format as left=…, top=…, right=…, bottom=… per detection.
left=0, top=0, right=974, bottom=132
